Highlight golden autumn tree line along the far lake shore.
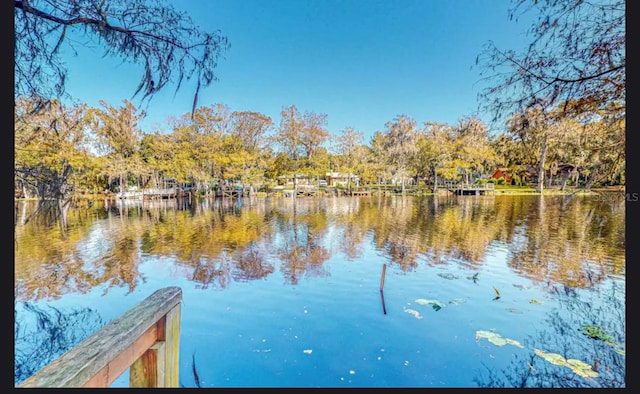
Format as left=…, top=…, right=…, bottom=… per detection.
left=15, top=97, right=625, bottom=200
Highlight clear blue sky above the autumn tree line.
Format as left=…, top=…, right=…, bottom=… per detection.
left=60, top=0, right=529, bottom=142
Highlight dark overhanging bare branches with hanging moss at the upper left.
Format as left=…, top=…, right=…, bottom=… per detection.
left=14, top=0, right=230, bottom=115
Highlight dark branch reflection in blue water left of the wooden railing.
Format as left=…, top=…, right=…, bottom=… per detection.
left=14, top=302, right=104, bottom=384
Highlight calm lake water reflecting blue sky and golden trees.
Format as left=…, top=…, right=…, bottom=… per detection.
left=14, top=195, right=626, bottom=388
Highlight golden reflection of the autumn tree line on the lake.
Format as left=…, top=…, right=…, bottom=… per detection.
left=15, top=196, right=625, bottom=301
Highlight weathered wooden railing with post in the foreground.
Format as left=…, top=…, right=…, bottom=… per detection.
left=18, top=287, right=182, bottom=387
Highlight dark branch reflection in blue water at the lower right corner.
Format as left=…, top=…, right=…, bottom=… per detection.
left=474, top=282, right=626, bottom=388
